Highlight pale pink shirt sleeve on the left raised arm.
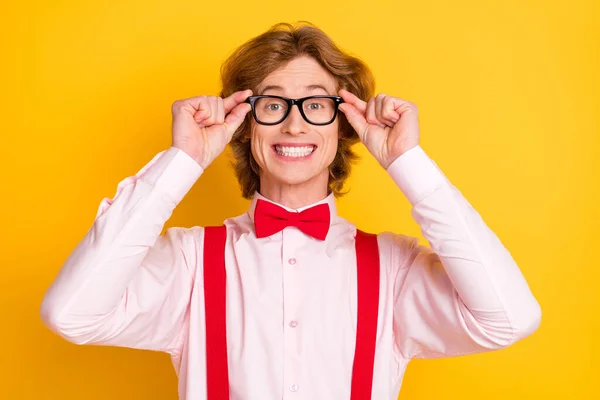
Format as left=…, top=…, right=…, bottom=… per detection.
left=40, top=147, right=203, bottom=352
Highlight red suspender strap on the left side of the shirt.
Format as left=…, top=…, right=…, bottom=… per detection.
left=204, top=226, right=229, bottom=400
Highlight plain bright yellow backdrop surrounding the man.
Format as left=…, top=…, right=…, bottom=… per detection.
left=0, top=0, right=600, bottom=400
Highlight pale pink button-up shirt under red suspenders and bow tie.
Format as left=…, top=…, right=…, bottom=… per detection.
left=41, top=146, right=541, bottom=400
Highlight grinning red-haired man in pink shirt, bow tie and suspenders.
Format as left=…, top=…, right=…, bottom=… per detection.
left=42, top=24, right=540, bottom=400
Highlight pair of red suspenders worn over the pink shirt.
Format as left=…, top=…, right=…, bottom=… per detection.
left=204, top=226, right=379, bottom=400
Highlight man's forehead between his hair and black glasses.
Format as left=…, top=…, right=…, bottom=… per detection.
left=258, top=56, right=337, bottom=95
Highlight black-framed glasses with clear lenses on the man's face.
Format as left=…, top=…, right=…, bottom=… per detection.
left=245, top=95, right=344, bottom=125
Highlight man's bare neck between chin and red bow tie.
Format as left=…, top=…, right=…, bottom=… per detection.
left=260, top=170, right=329, bottom=209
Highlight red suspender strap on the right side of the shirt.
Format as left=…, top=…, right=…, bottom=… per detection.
left=350, top=230, right=379, bottom=400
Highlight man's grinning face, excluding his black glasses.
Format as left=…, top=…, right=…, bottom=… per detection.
left=251, top=56, right=339, bottom=194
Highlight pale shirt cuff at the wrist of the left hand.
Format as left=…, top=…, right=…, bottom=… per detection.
left=138, top=146, right=204, bottom=203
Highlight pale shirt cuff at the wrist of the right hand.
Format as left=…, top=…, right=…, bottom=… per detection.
left=387, top=146, right=446, bottom=206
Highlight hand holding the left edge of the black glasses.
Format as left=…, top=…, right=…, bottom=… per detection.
left=171, top=90, right=252, bottom=169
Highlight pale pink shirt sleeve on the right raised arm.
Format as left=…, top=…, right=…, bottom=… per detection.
left=388, top=146, right=541, bottom=359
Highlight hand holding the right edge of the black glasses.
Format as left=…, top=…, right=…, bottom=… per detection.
left=339, top=89, right=419, bottom=169
